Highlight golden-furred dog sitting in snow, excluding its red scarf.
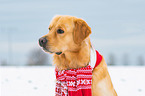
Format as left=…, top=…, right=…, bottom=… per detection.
left=39, top=15, right=117, bottom=96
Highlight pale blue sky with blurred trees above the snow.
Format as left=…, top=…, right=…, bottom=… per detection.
left=0, top=0, right=145, bottom=66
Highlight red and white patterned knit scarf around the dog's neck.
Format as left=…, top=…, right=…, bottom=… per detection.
left=55, top=51, right=102, bottom=96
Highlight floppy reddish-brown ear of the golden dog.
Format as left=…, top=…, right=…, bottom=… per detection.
left=73, top=19, right=91, bottom=44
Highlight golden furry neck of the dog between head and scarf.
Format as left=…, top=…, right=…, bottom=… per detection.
left=53, top=39, right=91, bottom=70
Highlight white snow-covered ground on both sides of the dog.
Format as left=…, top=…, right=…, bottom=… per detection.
left=0, top=67, right=145, bottom=96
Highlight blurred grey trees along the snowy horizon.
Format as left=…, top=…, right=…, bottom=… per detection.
left=0, top=48, right=145, bottom=66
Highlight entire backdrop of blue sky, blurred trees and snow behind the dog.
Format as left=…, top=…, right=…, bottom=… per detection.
left=0, top=0, right=145, bottom=96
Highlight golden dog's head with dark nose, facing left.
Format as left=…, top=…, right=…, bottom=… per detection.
left=39, top=15, right=91, bottom=55
